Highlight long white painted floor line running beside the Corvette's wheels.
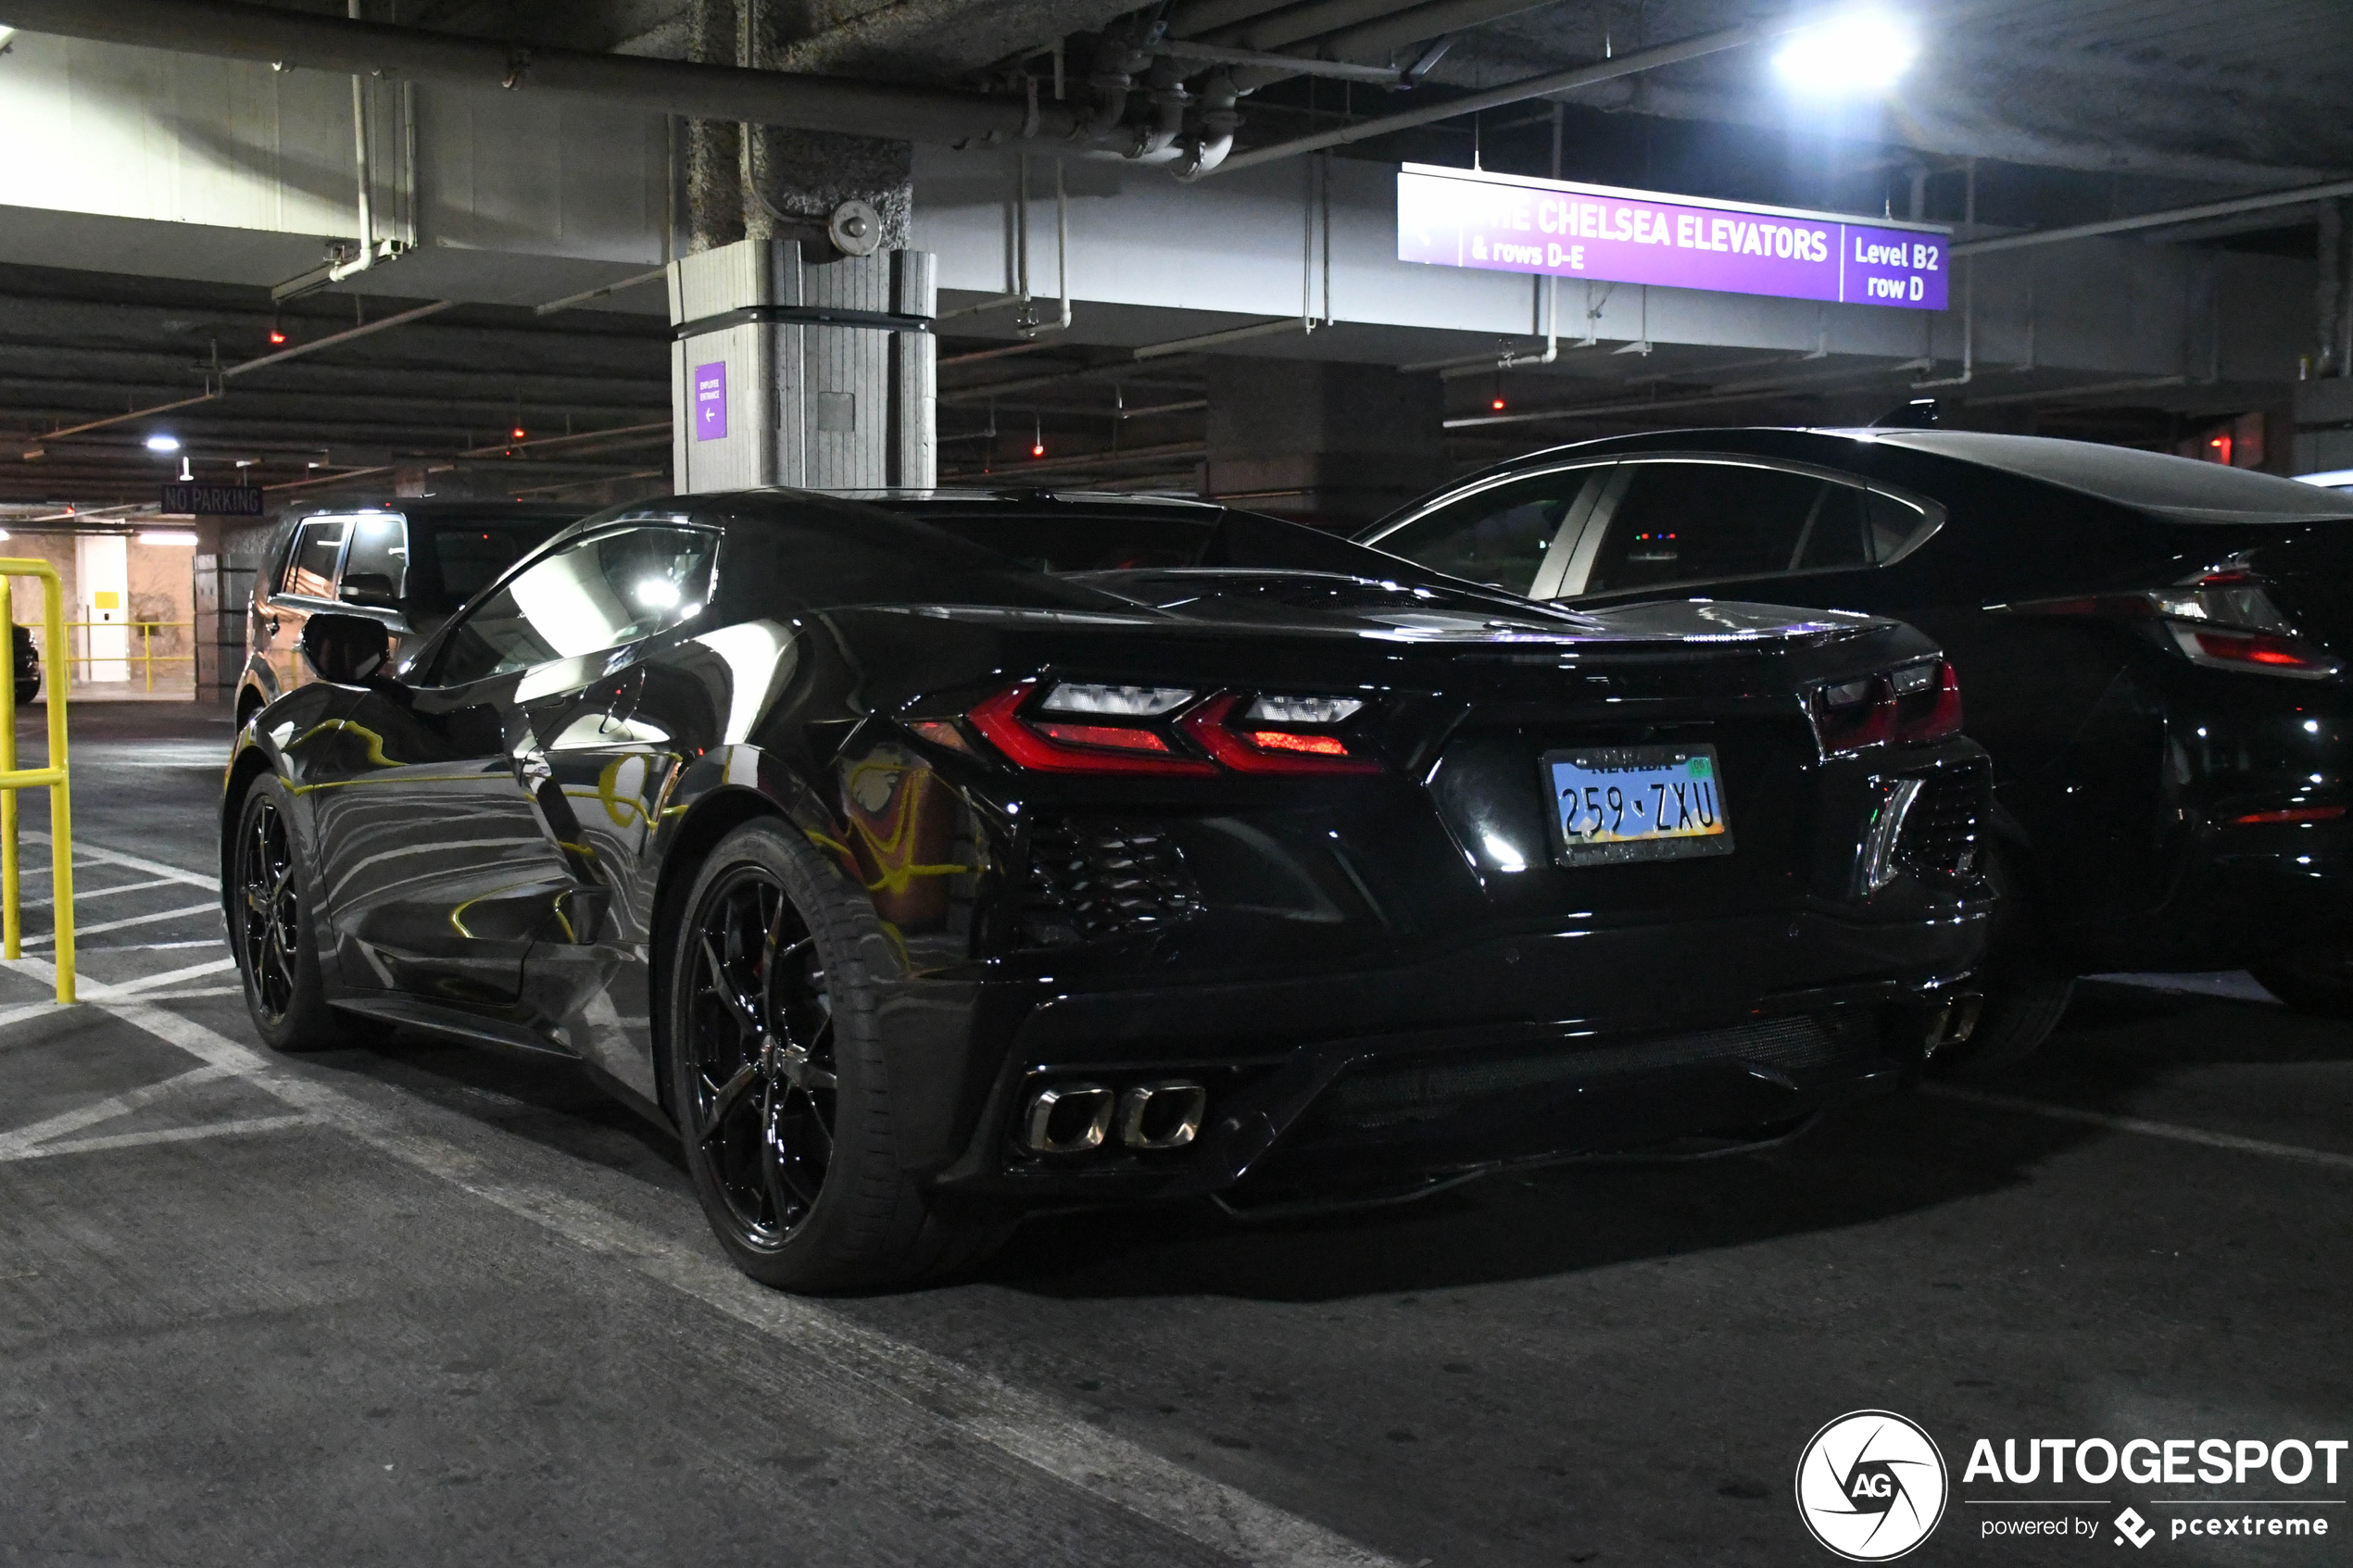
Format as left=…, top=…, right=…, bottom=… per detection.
left=101, top=1004, right=1400, bottom=1568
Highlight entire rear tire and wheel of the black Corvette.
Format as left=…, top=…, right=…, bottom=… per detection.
left=663, top=821, right=1010, bottom=1290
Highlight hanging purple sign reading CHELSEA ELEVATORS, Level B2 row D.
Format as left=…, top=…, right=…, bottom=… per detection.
left=1398, top=165, right=1951, bottom=310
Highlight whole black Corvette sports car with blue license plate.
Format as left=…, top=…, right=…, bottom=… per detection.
left=221, top=491, right=1988, bottom=1288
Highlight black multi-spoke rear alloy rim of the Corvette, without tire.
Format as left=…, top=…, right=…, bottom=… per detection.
left=683, top=863, right=837, bottom=1253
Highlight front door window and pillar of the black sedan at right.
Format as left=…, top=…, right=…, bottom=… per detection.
left=1358, top=460, right=1614, bottom=599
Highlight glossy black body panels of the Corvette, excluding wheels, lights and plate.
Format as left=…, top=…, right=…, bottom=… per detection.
left=223, top=494, right=1988, bottom=1201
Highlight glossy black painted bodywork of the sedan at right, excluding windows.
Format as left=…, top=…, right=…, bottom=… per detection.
left=1360, top=428, right=2353, bottom=973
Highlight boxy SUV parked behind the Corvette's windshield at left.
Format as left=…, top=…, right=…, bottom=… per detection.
left=235, top=501, right=581, bottom=724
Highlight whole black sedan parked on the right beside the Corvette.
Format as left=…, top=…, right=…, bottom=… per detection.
left=1360, top=430, right=2353, bottom=1065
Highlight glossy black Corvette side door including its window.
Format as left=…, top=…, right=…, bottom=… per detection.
left=318, top=527, right=715, bottom=1009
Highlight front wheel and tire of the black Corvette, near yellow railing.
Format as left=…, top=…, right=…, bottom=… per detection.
left=228, top=776, right=343, bottom=1051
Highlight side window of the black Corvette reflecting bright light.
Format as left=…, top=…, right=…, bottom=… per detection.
left=433, top=529, right=718, bottom=686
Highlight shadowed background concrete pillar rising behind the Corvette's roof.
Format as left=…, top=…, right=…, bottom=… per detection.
left=1202, top=358, right=1447, bottom=529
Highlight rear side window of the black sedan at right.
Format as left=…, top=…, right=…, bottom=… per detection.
left=1583, top=463, right=1869, bottom=593
